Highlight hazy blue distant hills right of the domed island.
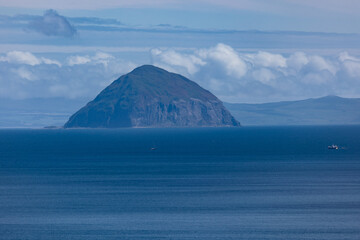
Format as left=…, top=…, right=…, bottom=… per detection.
left=224, top=96, right=360, bottom=126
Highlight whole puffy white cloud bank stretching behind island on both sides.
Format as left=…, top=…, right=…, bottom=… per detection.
left=0, top=43, right=360, bottom=103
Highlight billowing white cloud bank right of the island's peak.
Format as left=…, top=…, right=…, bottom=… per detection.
left=151, top=44, right=360, bottom=102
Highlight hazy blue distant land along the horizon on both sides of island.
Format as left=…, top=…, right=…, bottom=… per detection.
left=0, top=96, right=360, bottom=127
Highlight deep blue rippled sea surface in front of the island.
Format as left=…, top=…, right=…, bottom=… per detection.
left=0, top=126, right=360, bottom=240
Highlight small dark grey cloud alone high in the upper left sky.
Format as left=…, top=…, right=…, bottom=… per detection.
left=27, top=9, right=76, bottom=37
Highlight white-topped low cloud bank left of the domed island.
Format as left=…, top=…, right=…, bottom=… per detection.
left=0, top=51, right=136, bottom=99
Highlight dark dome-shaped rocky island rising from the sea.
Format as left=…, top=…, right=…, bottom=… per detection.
left=64, top=65, right=240, bottom=128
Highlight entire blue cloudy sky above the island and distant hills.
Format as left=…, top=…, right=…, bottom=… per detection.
left=0, top=0, right=360, bottom=103
